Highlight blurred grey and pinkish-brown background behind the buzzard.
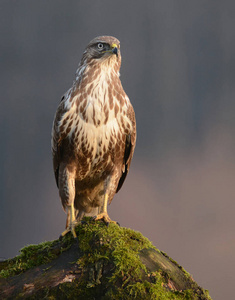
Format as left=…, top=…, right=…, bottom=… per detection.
left=0, top=0, right=235, bottom=300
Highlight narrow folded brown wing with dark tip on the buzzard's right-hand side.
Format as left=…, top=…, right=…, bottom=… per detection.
left=116, top=105, right=136, bottom=193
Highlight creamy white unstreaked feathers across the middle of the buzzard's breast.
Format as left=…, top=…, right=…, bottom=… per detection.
left=60, top=66, right=132, bottom=163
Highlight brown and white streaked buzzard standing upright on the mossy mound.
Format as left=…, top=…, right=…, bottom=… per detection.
left=52, top=36, right=136, bottom=237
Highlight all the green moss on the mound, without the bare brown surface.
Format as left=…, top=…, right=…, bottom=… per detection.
left=0, top=218, right=210, bottom=300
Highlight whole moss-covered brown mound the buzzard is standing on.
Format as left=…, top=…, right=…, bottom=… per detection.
left=0, top=218, right=211, bottom=300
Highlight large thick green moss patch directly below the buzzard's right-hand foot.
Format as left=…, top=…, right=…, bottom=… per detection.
left=69, top=219, right=210, bottom=300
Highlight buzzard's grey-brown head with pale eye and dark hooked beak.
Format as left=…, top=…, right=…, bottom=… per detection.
left=82, top=36, right=121, bottom=65
